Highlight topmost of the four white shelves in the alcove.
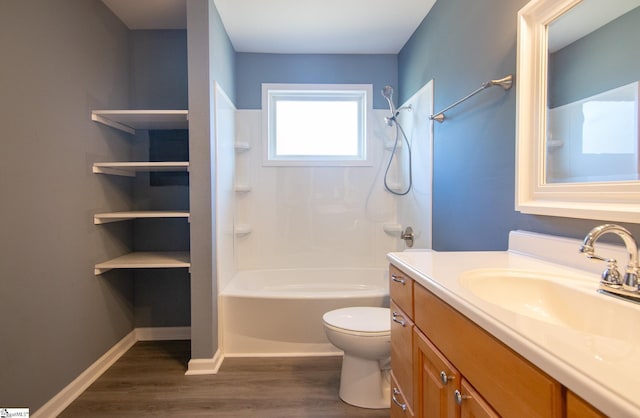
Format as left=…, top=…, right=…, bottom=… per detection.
left=91, top=110, right=189, bottom=135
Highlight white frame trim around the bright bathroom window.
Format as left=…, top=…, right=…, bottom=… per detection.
left=262, top=83, right=373, bottom=167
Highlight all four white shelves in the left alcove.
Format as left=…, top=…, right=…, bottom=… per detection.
left=91, top=110, right=191, bottom=275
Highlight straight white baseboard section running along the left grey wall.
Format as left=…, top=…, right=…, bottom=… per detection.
left=31, top=330, right=136, bottom=418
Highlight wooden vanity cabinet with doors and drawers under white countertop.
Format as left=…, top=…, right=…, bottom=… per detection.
left=390, top=266, right=576, bottom=418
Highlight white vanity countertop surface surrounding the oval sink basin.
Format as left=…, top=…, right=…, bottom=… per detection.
left=387, top=248, right=640, bottom=417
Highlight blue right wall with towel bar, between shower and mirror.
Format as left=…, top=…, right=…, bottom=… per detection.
left=398, top=0, right=640, bottom=250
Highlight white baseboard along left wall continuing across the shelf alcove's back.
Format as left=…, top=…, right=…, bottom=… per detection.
left=31, top=327, right=192, bottom=418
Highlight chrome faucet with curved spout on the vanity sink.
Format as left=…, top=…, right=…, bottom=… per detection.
left=580, top=224, right=640, bottom=301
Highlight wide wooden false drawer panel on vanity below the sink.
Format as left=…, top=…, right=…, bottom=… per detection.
left=414, top=285, right=562, bottom=418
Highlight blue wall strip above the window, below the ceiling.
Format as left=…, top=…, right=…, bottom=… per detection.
left=236, top=53, right=398, bottom=109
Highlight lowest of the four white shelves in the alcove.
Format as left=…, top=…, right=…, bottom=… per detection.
left=94, top=251, right=191, bottom=276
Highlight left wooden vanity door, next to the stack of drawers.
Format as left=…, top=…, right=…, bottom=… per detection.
left=413, top=327, right=460, bottom=418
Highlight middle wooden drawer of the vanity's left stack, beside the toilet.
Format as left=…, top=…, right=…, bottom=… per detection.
left=391, top=300, right=413, bottom=410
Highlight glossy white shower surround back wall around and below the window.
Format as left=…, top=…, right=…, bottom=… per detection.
left=235, top=110, right=399, bottom=270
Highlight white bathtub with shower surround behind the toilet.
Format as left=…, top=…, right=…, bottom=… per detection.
left=217, top=81, right=436, bottom=407
